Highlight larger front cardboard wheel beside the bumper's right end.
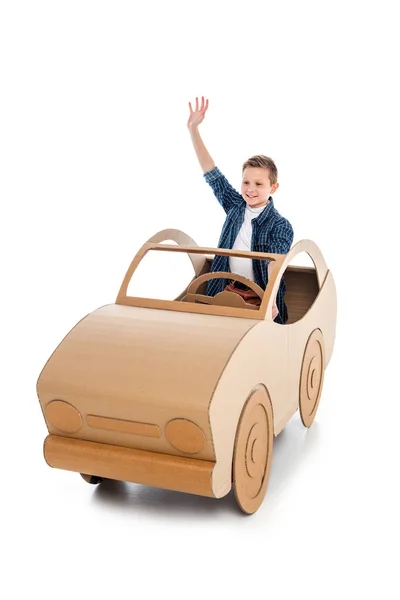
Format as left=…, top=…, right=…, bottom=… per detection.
left=233, top=386, right=274, bottom=514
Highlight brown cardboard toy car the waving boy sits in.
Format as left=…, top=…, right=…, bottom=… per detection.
left=37, top=230, right=336, bottom=514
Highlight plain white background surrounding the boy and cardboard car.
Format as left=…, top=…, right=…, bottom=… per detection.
left=0, top=0, right=400, bottom=600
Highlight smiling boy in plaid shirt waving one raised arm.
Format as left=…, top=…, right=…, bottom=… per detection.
left=187, top=96, right=293, bottom=324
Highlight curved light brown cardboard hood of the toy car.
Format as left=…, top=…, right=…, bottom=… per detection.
left=37, top=304, right=259, bottom=458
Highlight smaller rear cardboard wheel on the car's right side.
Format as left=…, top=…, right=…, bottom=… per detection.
left=299, top=329, right=325, bottom=427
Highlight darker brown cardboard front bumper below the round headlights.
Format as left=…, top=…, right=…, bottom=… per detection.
left=44, top=435, right=215, bottom=498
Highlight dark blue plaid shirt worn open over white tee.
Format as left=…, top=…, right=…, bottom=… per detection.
left=204, top=167, right=293, bottom=324
